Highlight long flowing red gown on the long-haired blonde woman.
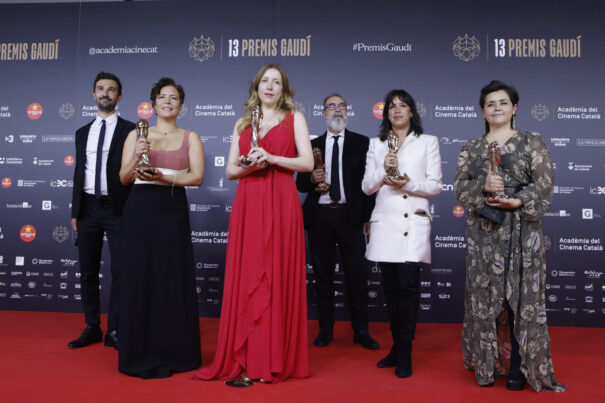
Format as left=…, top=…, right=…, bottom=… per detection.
left=194, top=113, right=311, bottom=382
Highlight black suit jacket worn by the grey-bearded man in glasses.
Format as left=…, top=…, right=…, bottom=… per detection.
left=296, top=129, right=375, bottom=228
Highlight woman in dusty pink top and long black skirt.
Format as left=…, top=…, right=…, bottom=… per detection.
left=118, top=78, right=204, bottom=378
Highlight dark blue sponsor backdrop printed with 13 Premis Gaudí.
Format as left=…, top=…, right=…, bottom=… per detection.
left=0, top=0, right=605, bottom=326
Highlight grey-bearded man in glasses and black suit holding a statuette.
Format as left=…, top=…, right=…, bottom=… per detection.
left=296, top=94, right=379, bottom=350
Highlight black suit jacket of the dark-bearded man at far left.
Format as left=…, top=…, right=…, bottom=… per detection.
left=71, top=116, right=135, bottom=218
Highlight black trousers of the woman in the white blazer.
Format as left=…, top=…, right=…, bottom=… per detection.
left=380, top=262, right=420, bottom=344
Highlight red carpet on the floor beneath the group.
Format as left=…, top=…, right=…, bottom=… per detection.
left=0, top=311, right=605, bottom=403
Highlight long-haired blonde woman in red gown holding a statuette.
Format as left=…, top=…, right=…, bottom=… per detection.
left=194, top=64, right=313, bottom=382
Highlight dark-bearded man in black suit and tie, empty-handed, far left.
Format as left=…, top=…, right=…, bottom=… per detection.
left=67, top=72, right=135, bottom=348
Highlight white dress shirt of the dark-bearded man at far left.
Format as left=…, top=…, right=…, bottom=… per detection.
left=84, top=113, right=118, bottom=196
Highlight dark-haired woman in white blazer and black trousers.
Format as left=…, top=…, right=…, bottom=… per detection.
left=361, top=90, right=442, bottom=378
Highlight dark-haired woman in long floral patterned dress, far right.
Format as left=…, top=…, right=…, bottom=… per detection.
left=454, top=81, right=565, bottom=392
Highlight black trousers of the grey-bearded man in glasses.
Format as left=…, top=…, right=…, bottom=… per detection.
left=308, top=205, right=370, bottom=333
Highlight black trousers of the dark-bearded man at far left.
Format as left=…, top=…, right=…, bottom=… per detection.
left=77, top=195, right=120, bottom=331
